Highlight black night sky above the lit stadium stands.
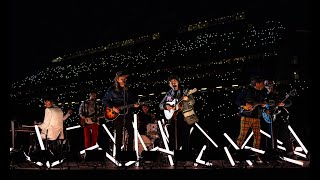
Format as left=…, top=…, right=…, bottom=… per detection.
left=8, top=0, right=311, bottom=82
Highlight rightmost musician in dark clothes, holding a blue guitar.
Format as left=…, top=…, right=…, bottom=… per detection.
left=264, top=80, right=296, bottom=159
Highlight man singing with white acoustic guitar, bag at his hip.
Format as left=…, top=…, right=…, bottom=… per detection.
left=159, top=75, right=198, bottom=152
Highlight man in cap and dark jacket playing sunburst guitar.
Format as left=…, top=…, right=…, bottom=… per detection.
left=102, top=71, right=139, bottom=152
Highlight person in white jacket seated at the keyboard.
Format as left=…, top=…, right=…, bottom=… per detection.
left=38, top=98, right=72, bottom=140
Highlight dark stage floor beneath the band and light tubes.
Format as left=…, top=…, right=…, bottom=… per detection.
left=10, top=159, right=311, bottom=179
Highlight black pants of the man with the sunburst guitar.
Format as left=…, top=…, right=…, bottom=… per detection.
left=114, top=115, right=134, bottom=152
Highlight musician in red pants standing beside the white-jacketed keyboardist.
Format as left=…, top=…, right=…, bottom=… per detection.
left=79, top=90, right=102, bottom=149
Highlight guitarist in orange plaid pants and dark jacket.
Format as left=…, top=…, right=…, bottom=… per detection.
left=235, top=76, right=266, bottom=163
